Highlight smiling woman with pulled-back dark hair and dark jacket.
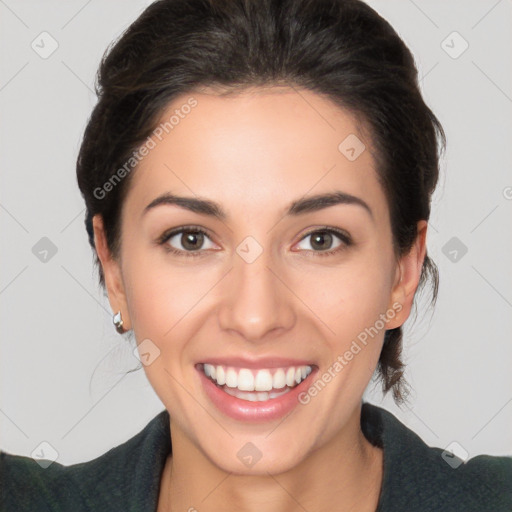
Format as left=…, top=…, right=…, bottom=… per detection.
left=1, top=0, right=512, bottom=512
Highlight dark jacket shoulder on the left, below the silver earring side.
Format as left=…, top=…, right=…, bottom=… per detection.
left=0, top=410, right=171, bottom=512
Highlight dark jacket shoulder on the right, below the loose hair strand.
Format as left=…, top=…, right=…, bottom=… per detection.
left=362, top=404, right=512, bottom=512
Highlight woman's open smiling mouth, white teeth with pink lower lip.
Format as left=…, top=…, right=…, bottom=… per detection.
left=195, top=362, right=318, bottom=421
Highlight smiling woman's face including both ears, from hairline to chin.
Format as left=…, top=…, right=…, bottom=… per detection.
left=95, top=88, right=424, bottom=474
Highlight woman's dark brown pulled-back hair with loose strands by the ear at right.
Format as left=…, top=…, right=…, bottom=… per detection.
left=77, top=0, right=445, bottom=401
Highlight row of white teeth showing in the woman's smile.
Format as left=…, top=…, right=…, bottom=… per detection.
left=203, top=363, right=312, bottom=394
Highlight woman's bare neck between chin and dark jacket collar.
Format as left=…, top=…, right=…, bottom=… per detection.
left=158, top=407, right=383, bottom=512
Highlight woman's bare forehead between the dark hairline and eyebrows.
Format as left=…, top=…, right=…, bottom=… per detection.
left=126, top=87, right=385, bottom=222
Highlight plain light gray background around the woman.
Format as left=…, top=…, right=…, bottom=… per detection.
left=0, top=0, right=512, bottom=464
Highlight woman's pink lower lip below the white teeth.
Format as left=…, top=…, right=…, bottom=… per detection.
left=197, top=367, right=317, bottom=422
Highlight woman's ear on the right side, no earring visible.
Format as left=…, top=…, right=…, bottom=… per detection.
left=386, top=220, right=427, bottom=329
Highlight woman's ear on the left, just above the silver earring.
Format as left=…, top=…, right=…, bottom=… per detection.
left=92, top=214, right=131, bottom=331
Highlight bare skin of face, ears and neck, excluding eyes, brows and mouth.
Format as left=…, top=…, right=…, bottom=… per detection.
left=94, top=87, right=426, bottom=512
